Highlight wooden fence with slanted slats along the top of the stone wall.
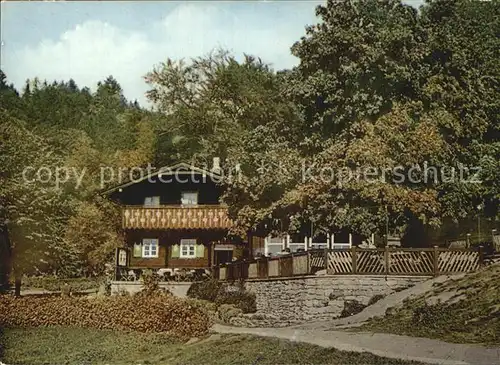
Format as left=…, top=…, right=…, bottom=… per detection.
left=214, top=247, right=484, bottom=280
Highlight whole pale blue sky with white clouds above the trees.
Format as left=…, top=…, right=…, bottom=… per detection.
left=0, top=0, right=421, bottom=106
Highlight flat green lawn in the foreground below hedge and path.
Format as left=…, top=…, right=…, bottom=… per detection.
left=0, top=327, right=426, bottom=365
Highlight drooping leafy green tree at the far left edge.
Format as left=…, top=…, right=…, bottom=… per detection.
left=0, top=112, right=72, bottom=295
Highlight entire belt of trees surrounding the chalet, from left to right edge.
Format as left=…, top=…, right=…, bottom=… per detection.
left=0, top=0, right=500, bottom=277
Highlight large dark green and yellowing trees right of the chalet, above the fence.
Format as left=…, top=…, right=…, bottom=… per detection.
left=213, top=0, right=500, bottom=244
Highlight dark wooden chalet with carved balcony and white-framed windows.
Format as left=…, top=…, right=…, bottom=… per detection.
left=104, top=158, right=245, bottom=269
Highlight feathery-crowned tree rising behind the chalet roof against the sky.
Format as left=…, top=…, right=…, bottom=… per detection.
left=145, top=50, right=298, bottom=162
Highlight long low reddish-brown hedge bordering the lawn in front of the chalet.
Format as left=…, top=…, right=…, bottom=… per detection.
left=0, top=295, right=211, bottom=337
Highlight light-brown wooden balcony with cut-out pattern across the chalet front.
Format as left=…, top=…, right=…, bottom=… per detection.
left=123, top=205, right=232, bottom=229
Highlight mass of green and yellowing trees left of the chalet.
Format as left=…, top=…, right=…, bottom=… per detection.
left=0, top=73, right=156, bottom=277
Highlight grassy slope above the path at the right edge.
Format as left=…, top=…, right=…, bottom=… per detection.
left=357, top=264, right=500, bottom=345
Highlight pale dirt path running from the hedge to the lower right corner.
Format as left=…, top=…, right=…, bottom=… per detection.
left=213, top=325, right=500, bottom=365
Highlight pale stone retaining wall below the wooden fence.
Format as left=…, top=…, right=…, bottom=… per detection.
left=231, top=275, right=429, bottom=327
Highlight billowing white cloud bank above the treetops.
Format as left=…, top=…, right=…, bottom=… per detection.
left=4, top=3, right=314, bottom=105
